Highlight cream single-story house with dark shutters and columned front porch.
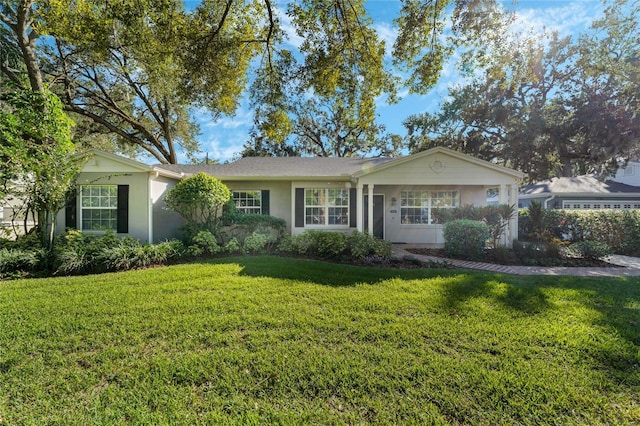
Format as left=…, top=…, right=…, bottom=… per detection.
left=58, top=148, right=524, bottom=245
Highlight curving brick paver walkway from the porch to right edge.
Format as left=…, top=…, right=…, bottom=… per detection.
left=393, top=244, right=640, bottom=277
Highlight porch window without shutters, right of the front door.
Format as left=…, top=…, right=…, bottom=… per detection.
left=400, top=191, right=459, bottom=225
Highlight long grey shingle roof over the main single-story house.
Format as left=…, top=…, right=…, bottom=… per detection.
left=155, top=157, right=394, bottom=178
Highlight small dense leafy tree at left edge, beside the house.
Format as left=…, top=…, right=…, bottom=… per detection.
left=0, top=89, right=81, bottom=248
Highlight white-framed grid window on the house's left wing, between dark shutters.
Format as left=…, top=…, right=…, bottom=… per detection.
left=80, top=185, right=118, bottom=231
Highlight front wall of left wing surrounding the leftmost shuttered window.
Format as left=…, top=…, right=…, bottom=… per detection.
left=56, top=172, right=151, bottom=242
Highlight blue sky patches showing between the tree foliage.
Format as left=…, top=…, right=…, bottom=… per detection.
left=186, top=0, right=604, bottom=162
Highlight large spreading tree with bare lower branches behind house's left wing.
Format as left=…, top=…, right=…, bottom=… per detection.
left=0, top=0, right=275, bottom=163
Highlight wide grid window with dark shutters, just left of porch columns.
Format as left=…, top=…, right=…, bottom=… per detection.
left=304, top=188, right=349, bottom=226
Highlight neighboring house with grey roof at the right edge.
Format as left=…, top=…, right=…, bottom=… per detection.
left=518, top=175, right=640, bottom=209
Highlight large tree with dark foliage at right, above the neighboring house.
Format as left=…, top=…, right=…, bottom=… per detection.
left=405, top=2, right=640, bottom=180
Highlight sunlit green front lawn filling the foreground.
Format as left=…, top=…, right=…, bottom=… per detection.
left=0, top=257, right=640, bottom=425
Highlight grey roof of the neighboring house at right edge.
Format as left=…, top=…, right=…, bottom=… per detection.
left=520, top=175, right=640, bottom=195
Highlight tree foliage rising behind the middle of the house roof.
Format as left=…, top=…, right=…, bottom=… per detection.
left=246, top=0, right=397, bottom=157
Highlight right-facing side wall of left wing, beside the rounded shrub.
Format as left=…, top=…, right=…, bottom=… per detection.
left=149, top=176, right=185, bottom=243
